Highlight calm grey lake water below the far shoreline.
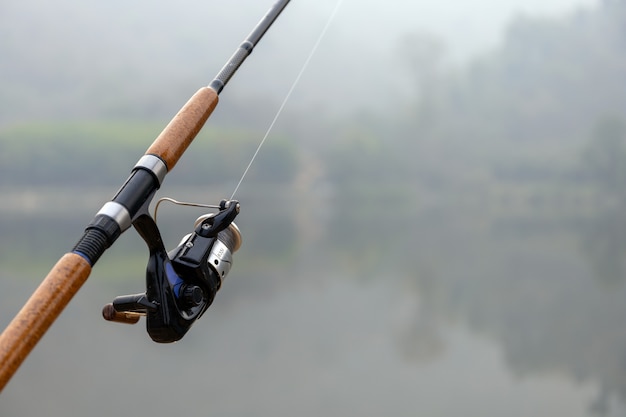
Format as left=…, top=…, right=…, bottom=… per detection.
left=0, top=189, right=626, bottom=417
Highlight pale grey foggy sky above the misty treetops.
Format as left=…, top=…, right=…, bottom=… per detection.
left=0, top=0, right=601, bottom=118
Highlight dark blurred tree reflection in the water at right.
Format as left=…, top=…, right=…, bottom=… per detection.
left=324, top=186, right=626, bottom=415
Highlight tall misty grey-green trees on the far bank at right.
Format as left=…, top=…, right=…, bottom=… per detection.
left=386, top=1, right=626, bottom=193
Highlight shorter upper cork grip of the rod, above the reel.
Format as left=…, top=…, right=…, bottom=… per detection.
left=146, top=87, right=219, bottom=171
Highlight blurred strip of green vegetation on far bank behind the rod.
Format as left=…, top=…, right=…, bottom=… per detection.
left=0, top=120, right=296, bottom=186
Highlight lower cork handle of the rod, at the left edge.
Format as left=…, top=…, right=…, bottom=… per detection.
left=0, top=253, right=91, bottom=391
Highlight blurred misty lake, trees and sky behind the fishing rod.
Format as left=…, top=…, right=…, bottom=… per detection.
left=0, top=0, right=626, bottom=417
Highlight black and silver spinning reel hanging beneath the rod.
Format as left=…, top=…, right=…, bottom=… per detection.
left=102, top=200, right=241, bottom=343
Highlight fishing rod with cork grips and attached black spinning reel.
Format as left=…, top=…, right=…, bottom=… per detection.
left=0, top=0, right=289, bottom=391
